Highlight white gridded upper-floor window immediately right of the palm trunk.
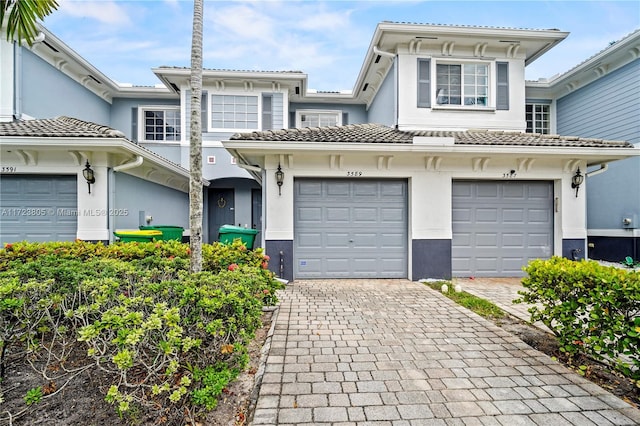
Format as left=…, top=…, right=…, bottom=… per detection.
left=211, top=95, right=258, bottom=130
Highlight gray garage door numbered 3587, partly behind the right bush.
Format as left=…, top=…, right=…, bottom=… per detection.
left=451, top=181, right=553, bottom=277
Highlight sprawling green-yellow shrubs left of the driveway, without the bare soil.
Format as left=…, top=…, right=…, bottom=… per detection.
left=0, top=241, right=281, bottom=421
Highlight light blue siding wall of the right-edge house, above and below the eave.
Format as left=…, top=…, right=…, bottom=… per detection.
left=557, top=59, right=640, bottom=229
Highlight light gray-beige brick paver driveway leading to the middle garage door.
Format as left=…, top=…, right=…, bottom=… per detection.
left=253, top=280, right=640, bottom=426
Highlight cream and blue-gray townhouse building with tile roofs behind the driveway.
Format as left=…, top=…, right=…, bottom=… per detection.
left=0, top=22, right=638, bottom=280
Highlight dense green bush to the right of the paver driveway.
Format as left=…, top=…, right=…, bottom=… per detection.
left=516, top=257, right=640, bottom=380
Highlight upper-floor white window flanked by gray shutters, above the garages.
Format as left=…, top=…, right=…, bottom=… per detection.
left=417, top=58, right=509, bottom=110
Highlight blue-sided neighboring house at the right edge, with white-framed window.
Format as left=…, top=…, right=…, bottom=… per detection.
left=526, top=30, right=640, bottom=261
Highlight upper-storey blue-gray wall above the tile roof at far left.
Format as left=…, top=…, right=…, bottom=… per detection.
left=16, top=48, right=111, bottom=125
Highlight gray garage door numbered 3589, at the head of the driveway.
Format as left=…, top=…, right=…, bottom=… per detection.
left=294, top=179, right=408, bottom=278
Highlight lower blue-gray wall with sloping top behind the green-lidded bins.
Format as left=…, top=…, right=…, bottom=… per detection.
left=111, top=172, right=189, bottom=230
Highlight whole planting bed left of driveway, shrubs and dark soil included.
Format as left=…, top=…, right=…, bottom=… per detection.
left=0, top=241, right=282, bottom=425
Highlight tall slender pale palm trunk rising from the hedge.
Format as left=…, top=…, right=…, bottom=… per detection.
left=189, top=0, right=203, bottom=272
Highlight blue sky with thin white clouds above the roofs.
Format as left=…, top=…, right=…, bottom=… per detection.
left=44, top=0, right=640, bottom=90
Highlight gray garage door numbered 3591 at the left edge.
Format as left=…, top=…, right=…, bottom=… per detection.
left=0, top=175, right=78, bottom=244
